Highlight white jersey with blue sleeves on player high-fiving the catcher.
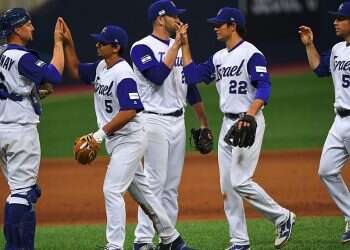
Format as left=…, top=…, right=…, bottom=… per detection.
left=79, top=60, right=143, bottom=140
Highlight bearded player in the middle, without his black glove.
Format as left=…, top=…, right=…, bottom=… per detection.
left=131, top=0, right=208, bottom=250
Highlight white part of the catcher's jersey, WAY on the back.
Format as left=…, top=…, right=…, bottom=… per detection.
left=0, top=49, right=39, bottom=124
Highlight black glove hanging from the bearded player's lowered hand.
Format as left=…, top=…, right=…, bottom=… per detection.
left=190, top=128, right=213, bottom=154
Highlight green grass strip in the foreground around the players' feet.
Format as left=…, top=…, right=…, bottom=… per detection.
left=0, top=217, right=350, bottom=250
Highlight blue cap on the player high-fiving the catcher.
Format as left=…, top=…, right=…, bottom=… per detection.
left=90, top=25, right=129, bottom=48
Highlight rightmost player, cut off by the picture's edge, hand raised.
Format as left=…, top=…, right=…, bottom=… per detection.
left=299, top=2, right=350, bottom=243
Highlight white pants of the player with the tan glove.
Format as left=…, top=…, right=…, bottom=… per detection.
left=103, top=130, right=179, bottom=249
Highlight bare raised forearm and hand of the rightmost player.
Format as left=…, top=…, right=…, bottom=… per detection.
left=298, top=25, right=320, bottom=70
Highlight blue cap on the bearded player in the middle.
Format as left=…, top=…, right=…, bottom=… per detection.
left=148, top=0, right=186, bottom=22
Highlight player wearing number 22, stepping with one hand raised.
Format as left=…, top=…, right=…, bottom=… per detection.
left=181, top=7, right=295, bottom=250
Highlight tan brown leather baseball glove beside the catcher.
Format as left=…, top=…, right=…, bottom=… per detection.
left=73, top=134, right=100, bottom=165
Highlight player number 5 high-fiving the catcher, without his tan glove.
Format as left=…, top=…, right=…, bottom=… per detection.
left=59, top=19, right=193, bottom=250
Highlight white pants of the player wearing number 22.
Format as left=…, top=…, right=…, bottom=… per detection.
left=218, top=112, right=289, bottom=245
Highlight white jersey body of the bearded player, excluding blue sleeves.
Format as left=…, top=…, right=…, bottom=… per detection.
left=131, top=35, right=187, bottom=114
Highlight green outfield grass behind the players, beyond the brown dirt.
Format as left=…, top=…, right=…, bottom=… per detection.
left=39, top=74, right=334, bottom=158
